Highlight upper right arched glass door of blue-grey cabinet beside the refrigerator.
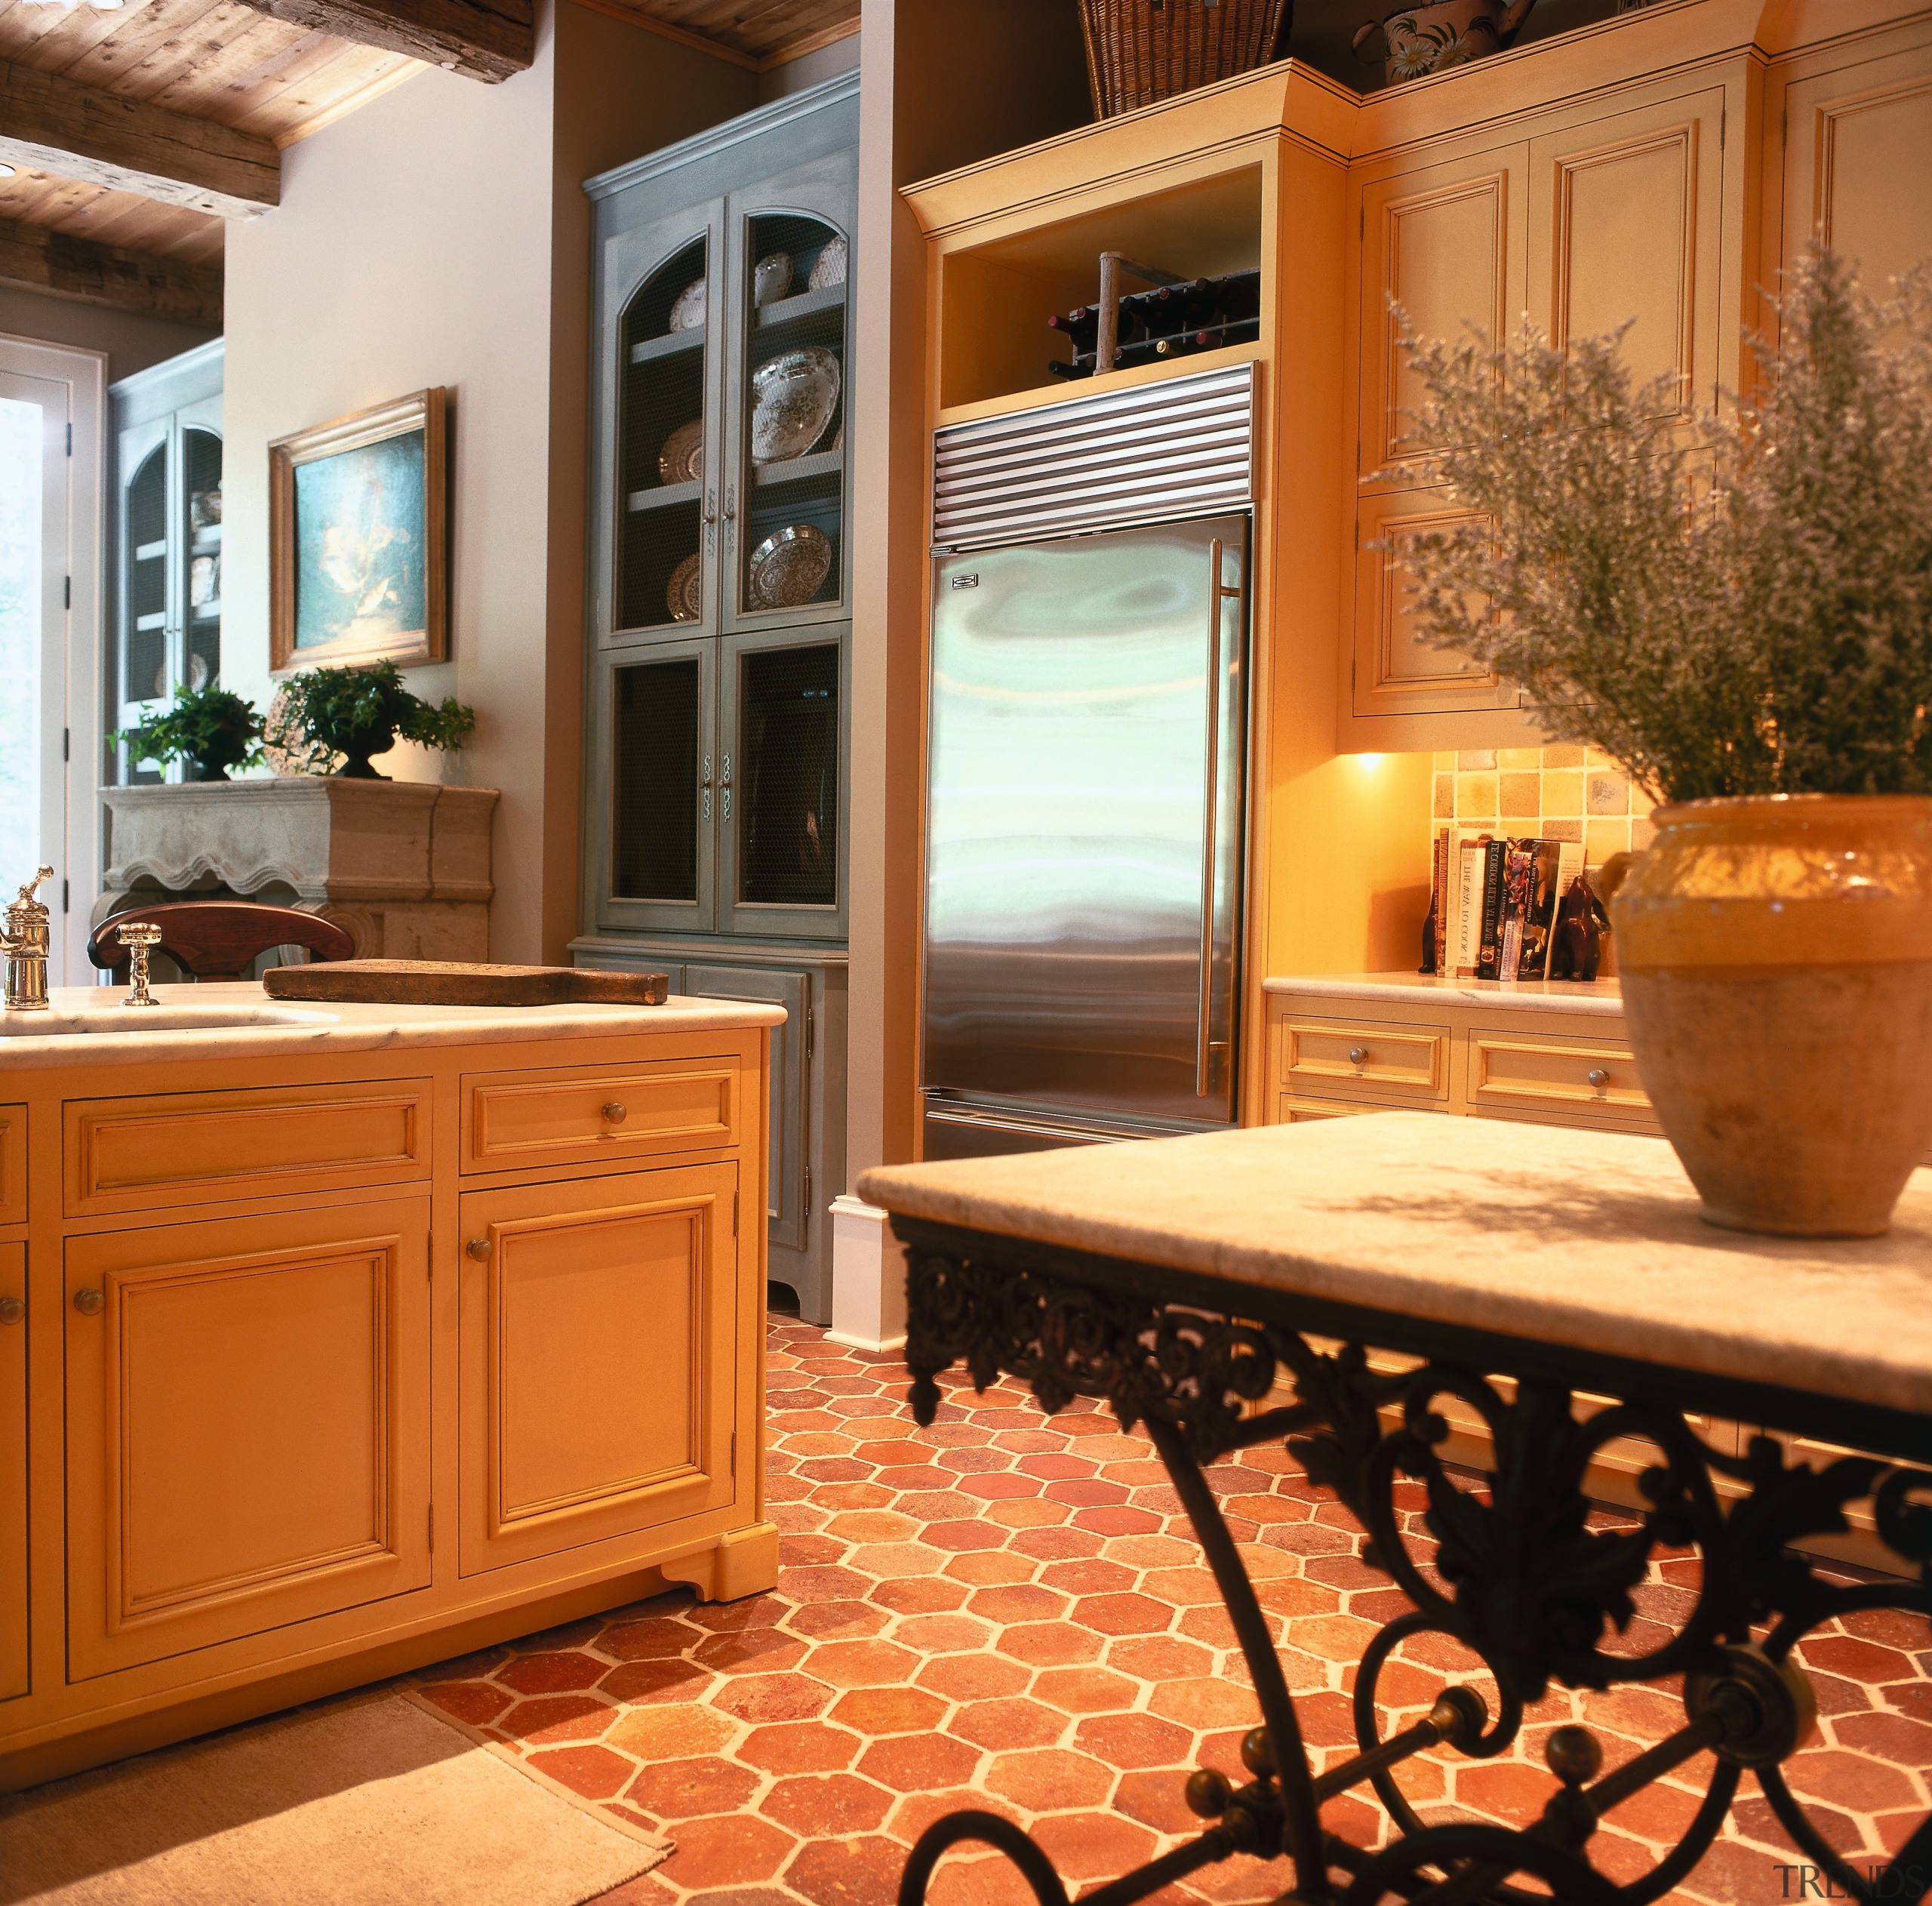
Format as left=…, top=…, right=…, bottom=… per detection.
left=721, top=149, right=858, bottom=630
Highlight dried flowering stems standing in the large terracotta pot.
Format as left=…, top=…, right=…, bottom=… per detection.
left=1404, top=249, right=1932, bottom=800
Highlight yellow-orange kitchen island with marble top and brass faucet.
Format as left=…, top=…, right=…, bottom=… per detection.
left=0, top=984, right=784, bottom=1788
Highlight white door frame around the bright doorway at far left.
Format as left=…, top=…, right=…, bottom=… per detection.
left=0, top=332, right=108, bottom=986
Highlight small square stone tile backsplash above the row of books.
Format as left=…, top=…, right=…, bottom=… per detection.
left=1434, top=742, right=1654, bottom=866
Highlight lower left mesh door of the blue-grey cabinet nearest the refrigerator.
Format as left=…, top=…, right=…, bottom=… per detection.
left=586, top=636, right=718, bottom=934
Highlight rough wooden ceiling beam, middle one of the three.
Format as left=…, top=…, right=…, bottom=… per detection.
left=0, top=60, right=282, bottom=218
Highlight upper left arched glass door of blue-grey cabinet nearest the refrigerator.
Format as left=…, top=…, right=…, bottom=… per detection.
left=593, top=203, right=724, bottom=642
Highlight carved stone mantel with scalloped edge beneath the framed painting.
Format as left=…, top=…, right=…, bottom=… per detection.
left=89, top=775, right=497, bottom=961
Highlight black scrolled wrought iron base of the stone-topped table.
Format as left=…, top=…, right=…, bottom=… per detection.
left=894, top=1218, right=1932, bottom=1906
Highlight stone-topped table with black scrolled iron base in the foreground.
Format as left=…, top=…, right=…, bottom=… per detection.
left=858, top=1111, right=1932, bottom=1906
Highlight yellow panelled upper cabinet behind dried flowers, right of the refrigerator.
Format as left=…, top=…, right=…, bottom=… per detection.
left=1341, top=35, right=1754, bottom=750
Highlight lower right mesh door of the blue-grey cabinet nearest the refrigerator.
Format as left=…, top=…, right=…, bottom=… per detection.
left=717, top=623, right=850, bottom=940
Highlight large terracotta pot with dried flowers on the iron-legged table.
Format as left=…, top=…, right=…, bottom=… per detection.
left=1408, top=251, right=1932, bottom=1235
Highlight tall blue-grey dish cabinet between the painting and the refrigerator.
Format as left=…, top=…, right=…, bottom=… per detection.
left=572, top=73, right=858, bottom=1322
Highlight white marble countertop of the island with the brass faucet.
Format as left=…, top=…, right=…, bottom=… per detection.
left=0, top=980, right=784, bottom=1071
